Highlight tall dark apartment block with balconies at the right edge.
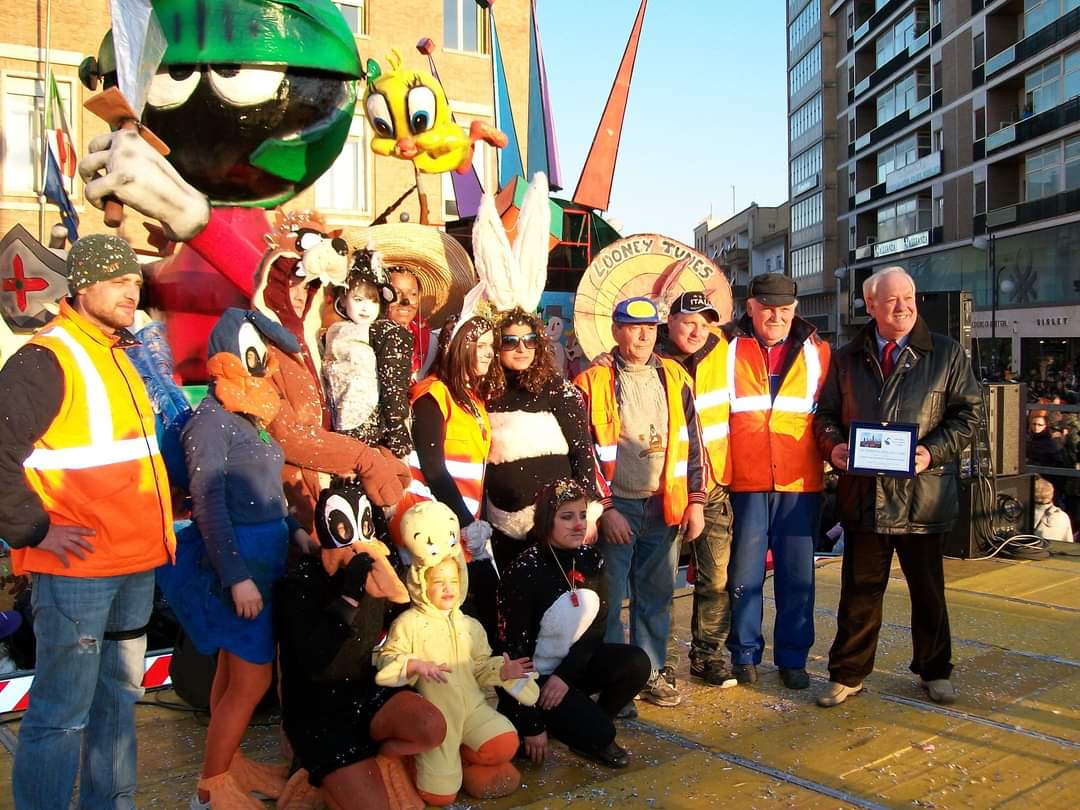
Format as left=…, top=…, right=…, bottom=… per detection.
left=833, top=0, right=1080, bottom=372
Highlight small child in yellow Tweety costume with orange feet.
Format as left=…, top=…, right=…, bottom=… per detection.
left=376, top=501, right=540, bottom=807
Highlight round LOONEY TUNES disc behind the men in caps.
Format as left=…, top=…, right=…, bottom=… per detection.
left=573, top=233, right=731, bottom=360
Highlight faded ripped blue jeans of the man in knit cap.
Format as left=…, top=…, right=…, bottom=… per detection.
left=12, top=570, right=153, bottom=810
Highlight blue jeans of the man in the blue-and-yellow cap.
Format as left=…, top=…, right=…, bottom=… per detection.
left=599, top=498, right=678, bottom=672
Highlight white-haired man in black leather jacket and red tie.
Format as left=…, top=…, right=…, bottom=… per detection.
left=814, top=267, right=982, bottom=706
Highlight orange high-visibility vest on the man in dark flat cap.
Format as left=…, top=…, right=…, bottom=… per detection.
left=728, top=337, right=829, bottom=492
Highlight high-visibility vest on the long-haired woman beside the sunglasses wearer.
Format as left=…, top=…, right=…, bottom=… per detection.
left=390, top=377, right=491, bottom=556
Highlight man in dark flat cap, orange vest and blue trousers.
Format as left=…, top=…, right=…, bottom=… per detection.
left=726, top=273, right=829, bottom=689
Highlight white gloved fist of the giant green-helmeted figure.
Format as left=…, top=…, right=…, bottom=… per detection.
left=79, top=130, right=210, bottom=242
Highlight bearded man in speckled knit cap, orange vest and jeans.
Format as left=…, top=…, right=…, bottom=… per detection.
left=0, top=234, right=176, bottom=810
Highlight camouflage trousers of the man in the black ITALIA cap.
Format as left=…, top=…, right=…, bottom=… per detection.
left=690, top=487, right=731, bottom=663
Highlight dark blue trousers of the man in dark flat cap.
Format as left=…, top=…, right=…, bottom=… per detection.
left=727, top=492, right=821, bottom=670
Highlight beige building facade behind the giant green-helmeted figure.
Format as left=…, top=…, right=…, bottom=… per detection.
left=0, top=0, right=529, bottom=249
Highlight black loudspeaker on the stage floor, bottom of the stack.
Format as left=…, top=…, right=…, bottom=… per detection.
left=945, top=475, right=1035, bottom=559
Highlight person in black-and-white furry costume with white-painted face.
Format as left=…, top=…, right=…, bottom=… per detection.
left=323, top=248, right=413, bottom=458
